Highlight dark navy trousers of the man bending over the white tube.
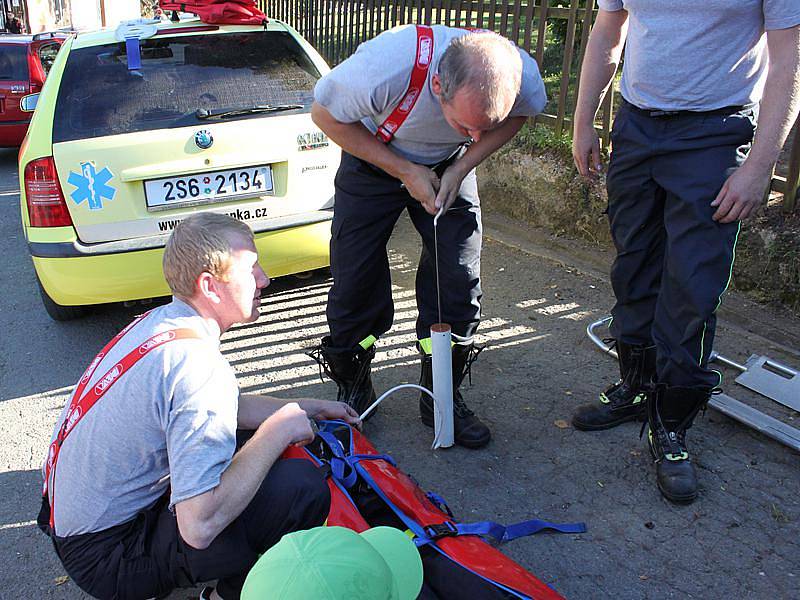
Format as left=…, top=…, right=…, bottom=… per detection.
left=327, top=152, right=482, bottom=348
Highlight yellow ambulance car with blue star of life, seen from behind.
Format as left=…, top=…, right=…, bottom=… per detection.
left=19, top=19, right=339, bottom=320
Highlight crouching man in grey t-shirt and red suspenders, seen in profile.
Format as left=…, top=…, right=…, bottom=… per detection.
left=39, top=213, right=358, bottom=600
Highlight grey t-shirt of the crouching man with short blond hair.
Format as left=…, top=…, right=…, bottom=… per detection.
left=44, top=299, right=239, bottom=537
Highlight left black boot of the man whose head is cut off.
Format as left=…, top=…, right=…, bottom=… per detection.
left=572, top=341, right=656, bottom=431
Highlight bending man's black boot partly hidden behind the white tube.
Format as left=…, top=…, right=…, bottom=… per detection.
left=417, top=343, right=492, bottom=449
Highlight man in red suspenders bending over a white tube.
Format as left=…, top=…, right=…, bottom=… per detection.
left=311, top=25, right=546, bottom=448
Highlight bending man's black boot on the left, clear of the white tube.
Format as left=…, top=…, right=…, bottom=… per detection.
left=308, top=336, right=375, bottom=419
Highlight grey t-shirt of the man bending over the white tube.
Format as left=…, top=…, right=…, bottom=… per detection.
left=314, top=25, right=547, bottom=165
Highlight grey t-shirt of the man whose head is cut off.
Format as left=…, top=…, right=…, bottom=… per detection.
left=599, top=0, right=800, bottom=111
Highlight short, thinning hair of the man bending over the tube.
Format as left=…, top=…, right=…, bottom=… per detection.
left=439, top=31, right=522, bottom=123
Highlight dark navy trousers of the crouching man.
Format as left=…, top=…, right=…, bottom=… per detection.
left=48, top=459, right=330, bottom=600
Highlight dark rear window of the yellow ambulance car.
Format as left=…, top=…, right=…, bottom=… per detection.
left=53, top=31, right=320, bottom=142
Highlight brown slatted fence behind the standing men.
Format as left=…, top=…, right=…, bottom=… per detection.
left=258, top=0, right=800, bottom=211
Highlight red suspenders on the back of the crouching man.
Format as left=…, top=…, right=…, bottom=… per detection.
left=42, top=312, right=200, bottom=532
